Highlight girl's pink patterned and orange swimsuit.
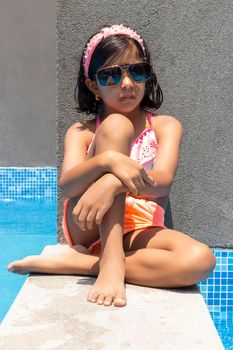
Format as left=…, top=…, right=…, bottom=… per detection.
left=62, top=112, right=166, bottom=254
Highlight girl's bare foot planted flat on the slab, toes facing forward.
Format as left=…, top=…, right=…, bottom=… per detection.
left=87, top=253, right=127, bottom=306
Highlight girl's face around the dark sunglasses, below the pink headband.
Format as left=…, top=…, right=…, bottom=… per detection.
left=86, top=45, right=145, bottom=115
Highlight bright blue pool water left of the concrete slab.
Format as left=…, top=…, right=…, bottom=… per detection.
left=0, top=199, right=57, bottom=321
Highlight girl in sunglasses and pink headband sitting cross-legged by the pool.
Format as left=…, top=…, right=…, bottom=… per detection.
left=8, top=25, right=215, bottom=306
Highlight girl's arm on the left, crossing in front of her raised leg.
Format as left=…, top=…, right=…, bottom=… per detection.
left=59, top=123, right=157, bottom=197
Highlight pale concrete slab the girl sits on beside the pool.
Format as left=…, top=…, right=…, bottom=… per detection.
left=0, top=245, right=224, bottom=350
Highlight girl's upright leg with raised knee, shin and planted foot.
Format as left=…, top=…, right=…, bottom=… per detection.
left=84, top=114, right=134, bottom=306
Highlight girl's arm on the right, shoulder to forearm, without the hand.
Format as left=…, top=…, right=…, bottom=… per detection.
left=103, top=116, right=183, bottom=199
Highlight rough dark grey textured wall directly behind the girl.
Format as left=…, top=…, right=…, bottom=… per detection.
left=57, top=0, right=233, bottom=247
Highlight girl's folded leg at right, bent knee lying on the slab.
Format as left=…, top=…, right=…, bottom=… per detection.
left=124, top=227, right=216, bottom=287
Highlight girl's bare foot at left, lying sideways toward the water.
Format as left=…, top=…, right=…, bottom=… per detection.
left=7, top=245, right=90, bottom=275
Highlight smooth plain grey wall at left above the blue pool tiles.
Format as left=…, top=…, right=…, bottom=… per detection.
left=0, top=0, right=56, bottom=166
